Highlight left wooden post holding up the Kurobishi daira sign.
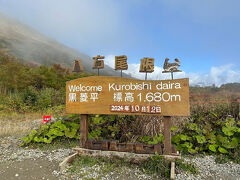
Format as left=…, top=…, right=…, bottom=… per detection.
left=80, top=114, right=88, bottom=148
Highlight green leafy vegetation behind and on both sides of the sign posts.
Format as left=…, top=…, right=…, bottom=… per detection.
left=23, top=104, right=240, bottom=163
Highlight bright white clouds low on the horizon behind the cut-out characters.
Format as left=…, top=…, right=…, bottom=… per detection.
left=105, top=55, right=240, bottom=86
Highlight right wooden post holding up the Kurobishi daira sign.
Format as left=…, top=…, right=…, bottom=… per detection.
left=163, top=116, right=172, bottom=155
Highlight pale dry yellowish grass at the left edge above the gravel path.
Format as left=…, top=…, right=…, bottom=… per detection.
left=0, top=113, right=42, bottom=137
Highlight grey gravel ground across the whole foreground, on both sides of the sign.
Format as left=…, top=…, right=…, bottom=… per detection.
left=0, top=137, right=240, bottom=180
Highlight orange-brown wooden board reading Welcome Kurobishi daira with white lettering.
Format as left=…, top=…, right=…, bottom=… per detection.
left=66, top=76, right=190, bottom=116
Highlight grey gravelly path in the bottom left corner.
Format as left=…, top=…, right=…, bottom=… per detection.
left=0, top=136, right=73, bottom=180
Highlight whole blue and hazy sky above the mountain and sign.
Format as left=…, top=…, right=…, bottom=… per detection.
left=0, top=0, right=240, bottom=86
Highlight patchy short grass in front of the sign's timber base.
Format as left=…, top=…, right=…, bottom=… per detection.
left=68, top=154, right=198, bottom=179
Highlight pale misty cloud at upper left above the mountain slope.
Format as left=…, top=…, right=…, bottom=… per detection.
left=0, top=0, right=122, bottom=49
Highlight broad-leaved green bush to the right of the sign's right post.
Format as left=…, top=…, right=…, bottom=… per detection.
left=172, top=104, right=240, bottom=162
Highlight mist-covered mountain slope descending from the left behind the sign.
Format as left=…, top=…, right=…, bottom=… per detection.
left=0, top=13, right=127, bottom=76
